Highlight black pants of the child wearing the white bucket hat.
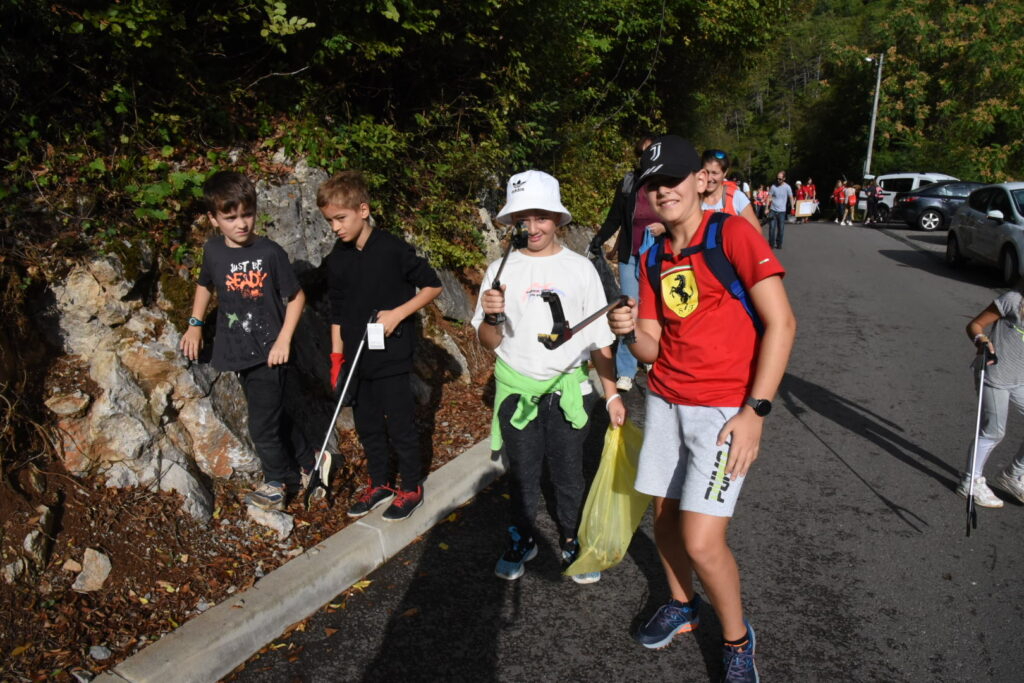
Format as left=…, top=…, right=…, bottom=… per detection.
left=498, top=393, right=595, bottom=539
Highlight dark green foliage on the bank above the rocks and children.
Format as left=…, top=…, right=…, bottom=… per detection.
left=0, top=0, right=788, bottom=274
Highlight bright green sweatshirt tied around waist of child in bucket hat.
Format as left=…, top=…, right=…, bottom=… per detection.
left=490, top=358, right=587, bottom=451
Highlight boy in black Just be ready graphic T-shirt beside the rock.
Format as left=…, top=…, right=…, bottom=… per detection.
left=181, top=171, right=314, bottom=510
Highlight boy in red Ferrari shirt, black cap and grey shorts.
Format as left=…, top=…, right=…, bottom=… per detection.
left=608, top=135, right=796, bottom=681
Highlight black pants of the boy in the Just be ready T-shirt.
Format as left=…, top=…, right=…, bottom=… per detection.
left=238, top=365, right=316, bottom=486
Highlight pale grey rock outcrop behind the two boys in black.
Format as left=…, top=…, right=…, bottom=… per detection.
left=44, top=161, right=495, bottom=520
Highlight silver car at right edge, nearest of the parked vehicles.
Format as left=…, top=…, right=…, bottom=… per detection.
left=946, top=182, right=1024, bottom=286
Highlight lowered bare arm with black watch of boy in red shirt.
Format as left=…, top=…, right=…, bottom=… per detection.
left=718, top=275, right=797, bottom=477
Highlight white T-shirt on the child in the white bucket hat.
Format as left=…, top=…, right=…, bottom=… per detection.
left=472, top=246, right=615, bottom=394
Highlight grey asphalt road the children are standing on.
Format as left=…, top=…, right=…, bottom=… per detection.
left=238, top=223, right=1024, bottom=681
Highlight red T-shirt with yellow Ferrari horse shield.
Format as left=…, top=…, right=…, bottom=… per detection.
left=638, top=211, right=785, bottom=407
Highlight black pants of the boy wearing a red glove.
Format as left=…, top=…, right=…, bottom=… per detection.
left=352, top=373, right=423, bottom=490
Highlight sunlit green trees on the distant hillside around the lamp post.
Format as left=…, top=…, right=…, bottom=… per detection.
left=693, top=0, right=1024, bottom=186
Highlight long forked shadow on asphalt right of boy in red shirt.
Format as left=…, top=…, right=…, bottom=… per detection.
left=779, top=374, right=958, bottom=532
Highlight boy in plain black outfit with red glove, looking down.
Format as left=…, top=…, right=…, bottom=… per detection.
left=316, top=171, right=441, bottom=521
